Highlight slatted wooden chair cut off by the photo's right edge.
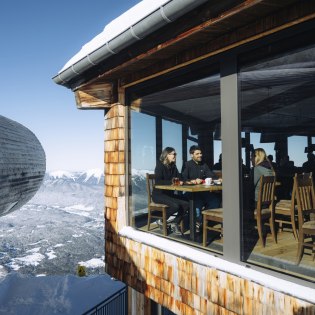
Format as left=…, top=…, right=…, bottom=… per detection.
left=295, top=176, right=315, bottom=264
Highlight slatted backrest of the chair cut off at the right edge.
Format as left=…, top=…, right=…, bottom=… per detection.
left=294, top=173, right=315, bottom=226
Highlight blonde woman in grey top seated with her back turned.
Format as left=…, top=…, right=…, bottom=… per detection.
left=252, top=148, right=275, bottom=205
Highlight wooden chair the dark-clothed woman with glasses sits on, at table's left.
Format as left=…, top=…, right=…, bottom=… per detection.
left=146, top=173, right=168, bottom=236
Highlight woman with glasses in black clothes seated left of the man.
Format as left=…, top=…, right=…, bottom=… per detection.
left=152, top=147, right=189, bottom=234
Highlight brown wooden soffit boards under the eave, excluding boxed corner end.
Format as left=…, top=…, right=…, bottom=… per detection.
left=95, top=0, right=315, bottom=88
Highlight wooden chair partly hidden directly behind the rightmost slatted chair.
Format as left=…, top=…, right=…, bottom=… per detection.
left=275, top=173, right=312, bottom=240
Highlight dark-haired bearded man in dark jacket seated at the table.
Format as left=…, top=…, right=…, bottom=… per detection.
left=182, top=145, right=221, bottom=232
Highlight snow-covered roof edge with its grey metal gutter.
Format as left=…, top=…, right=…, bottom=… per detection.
left=53, top=0, right=207, bottom=87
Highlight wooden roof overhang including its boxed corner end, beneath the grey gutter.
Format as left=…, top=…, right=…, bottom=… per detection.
left=54, top=0, right=315, bottom=109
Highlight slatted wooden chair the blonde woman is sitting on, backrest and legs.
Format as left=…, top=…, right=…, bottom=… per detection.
left=254, top=176, right=277, bottom=247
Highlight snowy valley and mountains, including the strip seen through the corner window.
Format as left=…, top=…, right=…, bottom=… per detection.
left=0, top=170, right=152, bottom=278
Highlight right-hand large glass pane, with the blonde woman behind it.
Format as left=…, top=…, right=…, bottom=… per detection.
left=239, top=41, right=315, bottom=281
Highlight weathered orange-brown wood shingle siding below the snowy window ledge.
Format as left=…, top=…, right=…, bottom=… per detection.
left=105, top=237, right=315, bottom=315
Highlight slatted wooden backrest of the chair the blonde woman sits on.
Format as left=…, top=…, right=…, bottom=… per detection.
left=257, top=175, right=276, bottom=211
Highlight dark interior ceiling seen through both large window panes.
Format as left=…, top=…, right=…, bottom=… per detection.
left=141, top=47, right=315, bottom=135
